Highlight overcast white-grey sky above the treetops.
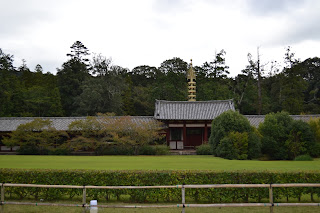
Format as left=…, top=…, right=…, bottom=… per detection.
left=0, top=0, right=320, bottom=76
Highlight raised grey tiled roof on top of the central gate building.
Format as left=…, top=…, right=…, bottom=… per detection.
left=154, top=100, right=235, bottom=120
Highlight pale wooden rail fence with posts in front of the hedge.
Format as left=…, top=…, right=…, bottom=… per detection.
left=0, top=183, right=320, bottom=212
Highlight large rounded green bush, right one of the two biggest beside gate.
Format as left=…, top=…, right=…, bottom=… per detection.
left=259, top=112, right=320, bottom=160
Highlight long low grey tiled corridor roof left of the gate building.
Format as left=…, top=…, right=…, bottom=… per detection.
left=0, top=116, right=154, bottom=132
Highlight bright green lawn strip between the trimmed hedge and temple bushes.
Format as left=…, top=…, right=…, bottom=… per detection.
left=0, top=155, right=320, bottom=171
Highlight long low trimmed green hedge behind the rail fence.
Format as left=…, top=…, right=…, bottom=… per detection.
left=0, top=169, right=320, bottom=202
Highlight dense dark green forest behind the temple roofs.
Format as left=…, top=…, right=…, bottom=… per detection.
left=0, top=41, right=320, bottom=117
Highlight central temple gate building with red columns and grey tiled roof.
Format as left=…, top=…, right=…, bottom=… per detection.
left=154, top=100, right=235, bottom=149
